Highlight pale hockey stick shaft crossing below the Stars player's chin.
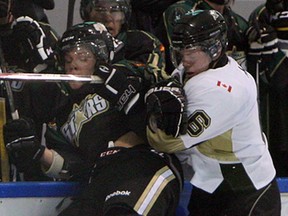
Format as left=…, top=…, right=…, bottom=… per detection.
left=0, top=73, right=103, bottom=84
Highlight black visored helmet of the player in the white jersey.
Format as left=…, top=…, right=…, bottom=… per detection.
left=171, top=10, right=227, bottom=66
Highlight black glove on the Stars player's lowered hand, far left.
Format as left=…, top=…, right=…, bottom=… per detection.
left=3, top=118, right=45, bottom=172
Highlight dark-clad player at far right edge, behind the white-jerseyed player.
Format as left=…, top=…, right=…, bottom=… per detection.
left=247, top=0, right=288, bottom=177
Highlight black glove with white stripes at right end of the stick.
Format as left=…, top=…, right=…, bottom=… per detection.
left=95, top=63, right=143, bottom=114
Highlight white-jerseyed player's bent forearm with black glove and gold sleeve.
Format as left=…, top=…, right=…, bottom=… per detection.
left=145, top=78, right=187, bottom=153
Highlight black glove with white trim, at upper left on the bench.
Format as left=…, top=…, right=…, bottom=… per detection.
left=11, top=16, right=53, bottom=69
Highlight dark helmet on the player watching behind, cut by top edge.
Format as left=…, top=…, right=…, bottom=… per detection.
left=80, top=0, right=131, bottom=26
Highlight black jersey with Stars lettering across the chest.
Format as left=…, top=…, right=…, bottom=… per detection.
left=44, top=61, right=157, bottom=181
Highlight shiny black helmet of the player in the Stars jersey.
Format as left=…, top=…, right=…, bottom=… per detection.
left=58, top=22, right=115, bottom=62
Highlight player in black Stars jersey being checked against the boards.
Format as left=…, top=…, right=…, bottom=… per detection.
left=4, top=22, right=181, bottom=216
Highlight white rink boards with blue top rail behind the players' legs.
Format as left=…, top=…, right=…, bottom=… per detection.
left=0, top=178, right=288, bottom=216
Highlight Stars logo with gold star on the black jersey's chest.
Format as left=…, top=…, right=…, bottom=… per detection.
left=61, top=94, right=109, bottom=146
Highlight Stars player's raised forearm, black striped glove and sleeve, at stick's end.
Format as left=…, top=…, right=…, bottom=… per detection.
left=95, top=60, right=163, bottom=114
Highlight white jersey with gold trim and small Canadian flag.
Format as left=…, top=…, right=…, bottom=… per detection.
left=148, top=57, right=275, bottom=193
